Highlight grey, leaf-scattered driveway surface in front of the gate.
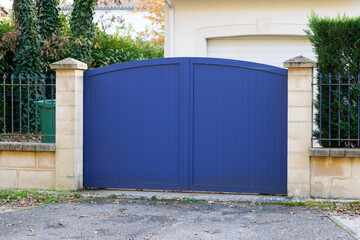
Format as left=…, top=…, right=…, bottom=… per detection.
left=0, top=198, right=354, bottom=240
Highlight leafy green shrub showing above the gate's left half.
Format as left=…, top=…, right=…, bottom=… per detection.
left=89, top=29, right=164, bottom=68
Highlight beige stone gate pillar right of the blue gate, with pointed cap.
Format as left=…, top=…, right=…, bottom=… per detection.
left=284, top=56, right=317, bottom=198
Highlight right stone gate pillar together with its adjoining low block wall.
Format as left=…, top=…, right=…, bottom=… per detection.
left=284, top=56, right=360, bottom=199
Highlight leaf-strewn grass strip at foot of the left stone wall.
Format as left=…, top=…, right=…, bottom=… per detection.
left=0, top=189, right=82, bottom=206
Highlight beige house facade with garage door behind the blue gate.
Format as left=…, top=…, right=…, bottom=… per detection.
left=165, top=0, right=360, bottom=67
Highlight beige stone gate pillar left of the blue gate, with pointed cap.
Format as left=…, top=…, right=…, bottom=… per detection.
left=51, top=58, right=87, bottom=190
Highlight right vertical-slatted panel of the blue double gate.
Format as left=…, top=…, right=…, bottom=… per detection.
left=190, top=63, right=287, bottom=193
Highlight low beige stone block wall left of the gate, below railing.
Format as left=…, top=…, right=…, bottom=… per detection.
left=0, top=143, right=55, bottom=189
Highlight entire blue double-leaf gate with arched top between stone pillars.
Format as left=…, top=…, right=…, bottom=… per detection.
left=84, top=58, right=287, bottom=194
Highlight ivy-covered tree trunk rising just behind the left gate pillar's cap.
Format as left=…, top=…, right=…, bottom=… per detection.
left=70, top=0, right=96, bottom=63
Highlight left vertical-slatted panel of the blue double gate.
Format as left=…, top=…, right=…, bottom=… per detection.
left=85, top=65, right=181, bottom=189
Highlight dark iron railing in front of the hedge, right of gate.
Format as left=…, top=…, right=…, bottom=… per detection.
left=313, top=73, right=360, bottom=148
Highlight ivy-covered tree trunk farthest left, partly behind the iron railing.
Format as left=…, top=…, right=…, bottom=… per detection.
left=14, top=0, right=43, bottom=131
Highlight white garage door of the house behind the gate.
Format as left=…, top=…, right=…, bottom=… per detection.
left=207, top=36, right=315, bottom=67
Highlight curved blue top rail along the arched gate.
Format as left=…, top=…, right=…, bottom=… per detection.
left=85, top=57, right=287, bottom=76
